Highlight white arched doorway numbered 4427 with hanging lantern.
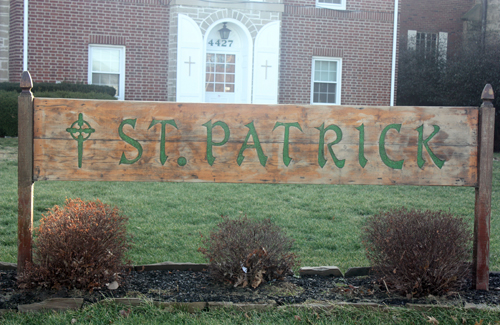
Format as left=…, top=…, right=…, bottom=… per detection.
left=204, top=19, right=252, bottom=103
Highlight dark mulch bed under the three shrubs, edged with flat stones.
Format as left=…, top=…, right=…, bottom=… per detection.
left=0, top=270, right=500, bottom=309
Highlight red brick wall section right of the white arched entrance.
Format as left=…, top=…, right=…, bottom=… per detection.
left=279, top=0, right=394, bottom=105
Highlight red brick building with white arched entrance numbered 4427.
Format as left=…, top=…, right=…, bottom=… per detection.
left=0, top=0, right=398, bottom=105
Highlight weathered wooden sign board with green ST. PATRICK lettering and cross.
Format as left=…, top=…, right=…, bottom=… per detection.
left=34, top=98, right=478, bottom=186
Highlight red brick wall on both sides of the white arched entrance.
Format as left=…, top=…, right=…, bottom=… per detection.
left=10, top=0, right=394, bottom=105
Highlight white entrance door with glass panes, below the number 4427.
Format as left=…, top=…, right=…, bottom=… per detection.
left=205, top=52, right=237, bottom=103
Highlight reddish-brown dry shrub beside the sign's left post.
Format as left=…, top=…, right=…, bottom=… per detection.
left=19, top=199, right=131, bottom=290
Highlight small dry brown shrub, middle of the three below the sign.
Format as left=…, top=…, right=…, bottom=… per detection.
left=199, top=217, right=298, bottom=288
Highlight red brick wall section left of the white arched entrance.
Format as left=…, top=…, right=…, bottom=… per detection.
left=9, top=0, right=169, bottom=100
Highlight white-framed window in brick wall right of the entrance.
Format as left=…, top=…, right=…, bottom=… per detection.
left=311, top=58, right=342, bottom=105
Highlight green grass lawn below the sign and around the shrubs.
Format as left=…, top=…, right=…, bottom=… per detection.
left=0, top=138, right=500, bottom=324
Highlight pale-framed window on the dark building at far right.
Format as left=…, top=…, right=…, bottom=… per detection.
left=408, top=30, right=448, bottom=60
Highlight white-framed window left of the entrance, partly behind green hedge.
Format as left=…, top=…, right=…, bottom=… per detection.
left=88, top=45, right=125, bottom=100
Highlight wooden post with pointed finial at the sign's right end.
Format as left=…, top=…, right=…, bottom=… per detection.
left=473, top=84, right=495, bottom=290
